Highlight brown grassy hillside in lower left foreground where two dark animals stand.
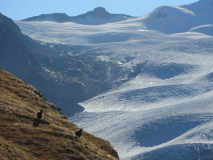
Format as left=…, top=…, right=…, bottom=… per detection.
left=0, top=69, right=119, bottom=160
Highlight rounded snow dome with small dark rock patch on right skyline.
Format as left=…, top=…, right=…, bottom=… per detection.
left=141, top=6, right=195, bottom=33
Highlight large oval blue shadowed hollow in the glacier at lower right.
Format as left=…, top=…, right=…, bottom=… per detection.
left=135, top=115, right=202, bottom=147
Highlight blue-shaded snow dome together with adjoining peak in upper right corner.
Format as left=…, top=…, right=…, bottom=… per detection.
left=130, top=0, right=213, bottom=34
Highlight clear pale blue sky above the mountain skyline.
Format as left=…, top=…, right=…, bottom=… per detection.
left=0, top=0, right=198, bottom=20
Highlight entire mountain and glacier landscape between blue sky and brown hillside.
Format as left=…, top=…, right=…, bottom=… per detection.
left=0, top=0, right=213, bottom=160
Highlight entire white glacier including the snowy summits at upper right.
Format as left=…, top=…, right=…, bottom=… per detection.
left=13, top=0, right=213, bottom=160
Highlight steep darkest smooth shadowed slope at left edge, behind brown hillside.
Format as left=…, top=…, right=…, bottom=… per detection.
left=0, top=14, right=83, bottom=113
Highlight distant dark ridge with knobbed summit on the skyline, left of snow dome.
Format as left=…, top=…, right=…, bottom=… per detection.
left=23, top=7, right=132, bottom=25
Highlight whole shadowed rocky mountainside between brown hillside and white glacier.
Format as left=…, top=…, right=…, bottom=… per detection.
left=0, top=14, right=126, bottom=116
